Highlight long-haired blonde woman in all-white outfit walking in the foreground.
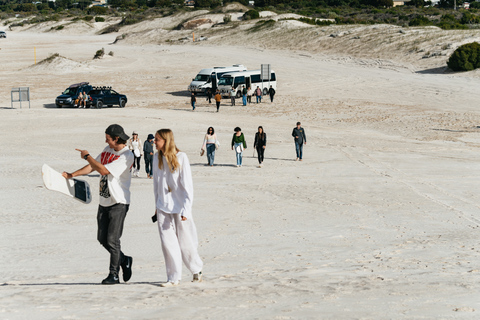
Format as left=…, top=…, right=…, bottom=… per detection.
left=153, top=129, right=203, bottom=287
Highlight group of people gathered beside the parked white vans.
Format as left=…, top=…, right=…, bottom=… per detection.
left=190, top=85, right=276, bottom=112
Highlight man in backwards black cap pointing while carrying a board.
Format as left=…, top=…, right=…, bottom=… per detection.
left=62, top=124, right=134, bottom=284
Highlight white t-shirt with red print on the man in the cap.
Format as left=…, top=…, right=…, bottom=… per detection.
left=95, top=146, right=134, bottom=207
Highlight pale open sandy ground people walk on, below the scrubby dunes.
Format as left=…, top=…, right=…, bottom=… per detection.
left=0, top=16, right=480, bottom=319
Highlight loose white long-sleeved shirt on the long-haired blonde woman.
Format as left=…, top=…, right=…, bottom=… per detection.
left=153, top=152, right=193, bottom=219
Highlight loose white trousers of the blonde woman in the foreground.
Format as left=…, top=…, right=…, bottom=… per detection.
left=157, top=210, right=203, bottom=282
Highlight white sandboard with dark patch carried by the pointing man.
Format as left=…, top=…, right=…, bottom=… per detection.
left=42, top=164, right=92, bottom=203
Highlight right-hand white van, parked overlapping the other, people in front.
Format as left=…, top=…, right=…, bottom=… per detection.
left=218, top=70, right=277, bottom=98
